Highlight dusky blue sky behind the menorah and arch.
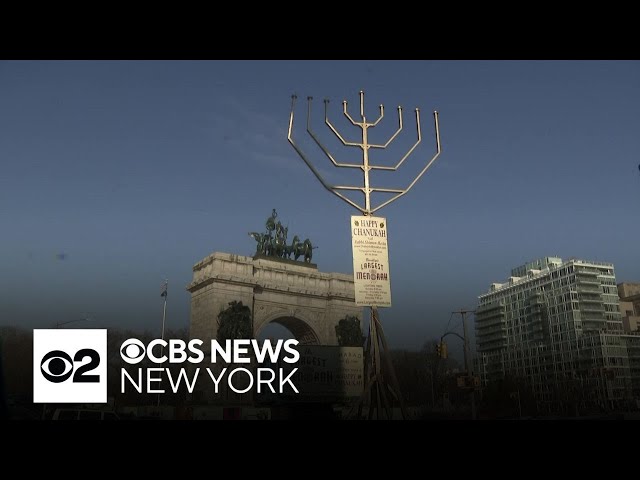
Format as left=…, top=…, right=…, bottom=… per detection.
left=0, top=60, right=640, bottom=349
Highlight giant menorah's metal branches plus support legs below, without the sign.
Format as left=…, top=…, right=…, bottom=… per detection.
left=287, top=91, right=440, bottom=419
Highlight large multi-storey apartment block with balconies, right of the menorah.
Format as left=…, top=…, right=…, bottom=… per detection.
left=475, top=257, right=635, bottom=411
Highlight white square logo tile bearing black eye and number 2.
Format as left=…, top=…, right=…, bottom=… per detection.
left=33, top=329, right=107, bottom=403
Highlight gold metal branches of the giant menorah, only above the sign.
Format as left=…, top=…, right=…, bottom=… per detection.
left=287, top=91, right=440, bottom=215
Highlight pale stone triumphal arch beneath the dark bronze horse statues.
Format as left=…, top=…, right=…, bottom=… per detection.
left=187, top=252, right=363, bottom=345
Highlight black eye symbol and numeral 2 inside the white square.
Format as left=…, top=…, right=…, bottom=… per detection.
left=40, top=348, right=100, bottom=383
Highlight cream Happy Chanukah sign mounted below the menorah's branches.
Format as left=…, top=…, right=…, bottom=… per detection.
left=351, top=215, right=391, bottom=307
